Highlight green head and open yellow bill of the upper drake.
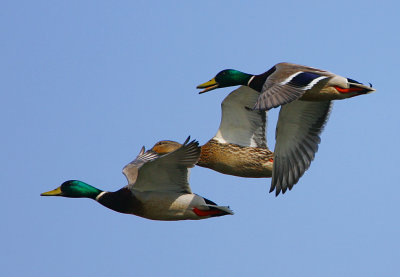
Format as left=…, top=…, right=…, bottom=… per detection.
left=197, top=69, right=253, bottom=93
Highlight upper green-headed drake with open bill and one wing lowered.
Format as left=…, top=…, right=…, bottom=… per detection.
left=197, top=63, right=375, bottom=195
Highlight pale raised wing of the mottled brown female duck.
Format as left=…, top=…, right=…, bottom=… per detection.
left=214, top=86, right=267, bottom=148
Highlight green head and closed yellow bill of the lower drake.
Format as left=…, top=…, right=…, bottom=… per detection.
left=40, top=180, right=102, bottom=199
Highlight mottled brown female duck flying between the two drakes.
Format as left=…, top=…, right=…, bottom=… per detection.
left=151, top=86, right=273, bottom=178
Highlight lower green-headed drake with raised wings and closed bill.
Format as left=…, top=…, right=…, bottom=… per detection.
left=41, top=138, right=233, bottom=220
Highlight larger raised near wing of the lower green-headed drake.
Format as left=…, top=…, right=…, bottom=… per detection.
left=133, top=137, right=201, bottom=193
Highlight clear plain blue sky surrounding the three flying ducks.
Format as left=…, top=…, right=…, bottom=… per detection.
left=0, top=0, right=400, bottom=277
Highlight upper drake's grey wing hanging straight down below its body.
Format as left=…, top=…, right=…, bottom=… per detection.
left=270, top=101, right=332, bottom=195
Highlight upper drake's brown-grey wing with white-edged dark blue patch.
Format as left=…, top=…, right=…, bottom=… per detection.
left=254, top=63, right=334, bottom=110
